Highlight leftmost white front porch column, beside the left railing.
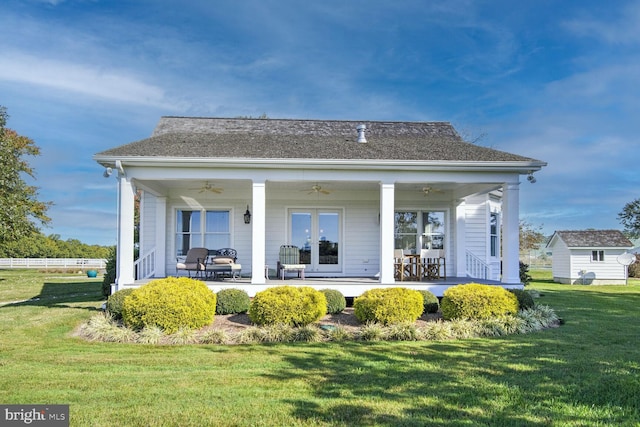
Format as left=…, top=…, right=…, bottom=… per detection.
left=116, top=172, right=135, bottom=290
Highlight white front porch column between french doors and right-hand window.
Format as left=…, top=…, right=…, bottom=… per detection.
left=380, top=183, right=395, bottom=284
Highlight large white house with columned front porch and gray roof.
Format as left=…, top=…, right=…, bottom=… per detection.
left=94, top=117, right=546, bottom=296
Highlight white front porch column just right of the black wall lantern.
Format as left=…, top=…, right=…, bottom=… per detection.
left=251, top=182, right=267, bottom=285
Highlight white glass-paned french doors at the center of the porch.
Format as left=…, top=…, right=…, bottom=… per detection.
left=289, top=209, right=342, bottom=273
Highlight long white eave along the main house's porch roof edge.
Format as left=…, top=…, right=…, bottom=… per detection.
left=93, top=155, right=547, bottom=174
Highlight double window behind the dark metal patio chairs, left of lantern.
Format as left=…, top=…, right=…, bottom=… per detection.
left=176, top=210, right=231, bottom=256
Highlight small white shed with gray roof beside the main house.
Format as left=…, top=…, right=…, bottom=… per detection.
left=547, top=230, right=633, bottom=285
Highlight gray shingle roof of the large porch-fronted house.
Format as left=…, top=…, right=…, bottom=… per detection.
left=96, top=117, right=544, bottom=165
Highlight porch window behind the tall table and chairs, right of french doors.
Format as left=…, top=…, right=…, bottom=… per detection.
left=395, top=211, right=446, bottom=253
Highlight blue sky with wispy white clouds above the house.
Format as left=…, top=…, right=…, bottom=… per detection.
left=0, top=0, right=640, bottom=245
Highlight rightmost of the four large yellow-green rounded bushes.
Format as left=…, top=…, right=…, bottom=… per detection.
left=440, top=283, right=518, bottom=320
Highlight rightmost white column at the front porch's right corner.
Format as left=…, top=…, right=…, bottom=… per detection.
left=502, top=182, right=520, bottom=284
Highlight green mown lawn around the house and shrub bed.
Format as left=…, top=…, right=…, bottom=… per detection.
left=0, top=270, right=640, bottom=426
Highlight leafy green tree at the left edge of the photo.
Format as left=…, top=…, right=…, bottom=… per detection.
left=0, top=107, right=51, bottom=244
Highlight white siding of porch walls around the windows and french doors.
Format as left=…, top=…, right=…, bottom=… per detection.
left=141, top=185, right=495, bottom=277
